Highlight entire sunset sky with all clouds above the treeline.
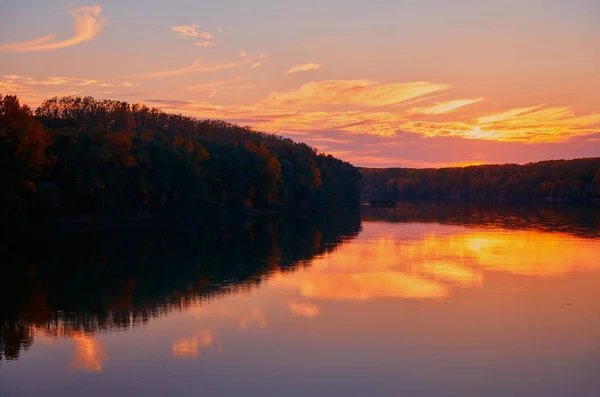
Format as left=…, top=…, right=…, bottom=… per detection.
left=0, top=0, right=600, bottom=168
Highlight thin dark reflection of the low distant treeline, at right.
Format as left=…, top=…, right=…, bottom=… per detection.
left=361, top=202, right=600, bottom=237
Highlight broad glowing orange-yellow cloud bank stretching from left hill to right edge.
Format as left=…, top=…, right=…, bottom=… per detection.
left=138, top=80, right=600, bottom=142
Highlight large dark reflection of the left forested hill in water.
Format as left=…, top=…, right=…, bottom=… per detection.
left=0, top=212, right=360, bottom=360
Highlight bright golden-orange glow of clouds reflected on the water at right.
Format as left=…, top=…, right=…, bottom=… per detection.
left=269, top=222, right=600, bottom=300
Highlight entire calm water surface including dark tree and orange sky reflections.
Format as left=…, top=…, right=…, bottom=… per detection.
left=0, top=206, right=600, bottom=397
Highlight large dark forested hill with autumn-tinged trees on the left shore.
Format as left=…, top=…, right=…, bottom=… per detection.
left=0, top=95, right=361, bottom=222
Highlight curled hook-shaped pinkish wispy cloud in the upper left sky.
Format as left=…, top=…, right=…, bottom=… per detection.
left=0, top=6, right=106, bottom=52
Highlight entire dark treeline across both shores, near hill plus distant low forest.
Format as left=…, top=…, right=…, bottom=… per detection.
left=0, top=95, right=600, bottom=224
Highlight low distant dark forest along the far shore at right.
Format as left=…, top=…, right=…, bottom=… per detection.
left=361, top=158, right=600, bottom=203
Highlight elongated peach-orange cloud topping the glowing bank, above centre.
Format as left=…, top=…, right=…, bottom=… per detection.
left=265, top=80, right=449, bottom=107
